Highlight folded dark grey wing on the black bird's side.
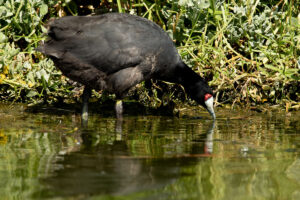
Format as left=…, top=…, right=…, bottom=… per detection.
left=41, top=16, right=153, bottom=74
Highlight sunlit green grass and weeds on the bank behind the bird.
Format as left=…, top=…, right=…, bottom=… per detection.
left=0, top=0, right=300, bottom=111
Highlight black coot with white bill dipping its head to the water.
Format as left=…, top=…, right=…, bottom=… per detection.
left=37, top=13, right=215, bottom=120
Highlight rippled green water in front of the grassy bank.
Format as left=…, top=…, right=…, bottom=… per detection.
left=0, top=105, right=300, bottom=200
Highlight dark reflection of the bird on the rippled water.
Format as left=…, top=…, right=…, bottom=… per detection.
left=41, top=118, right=213, bottom=197
